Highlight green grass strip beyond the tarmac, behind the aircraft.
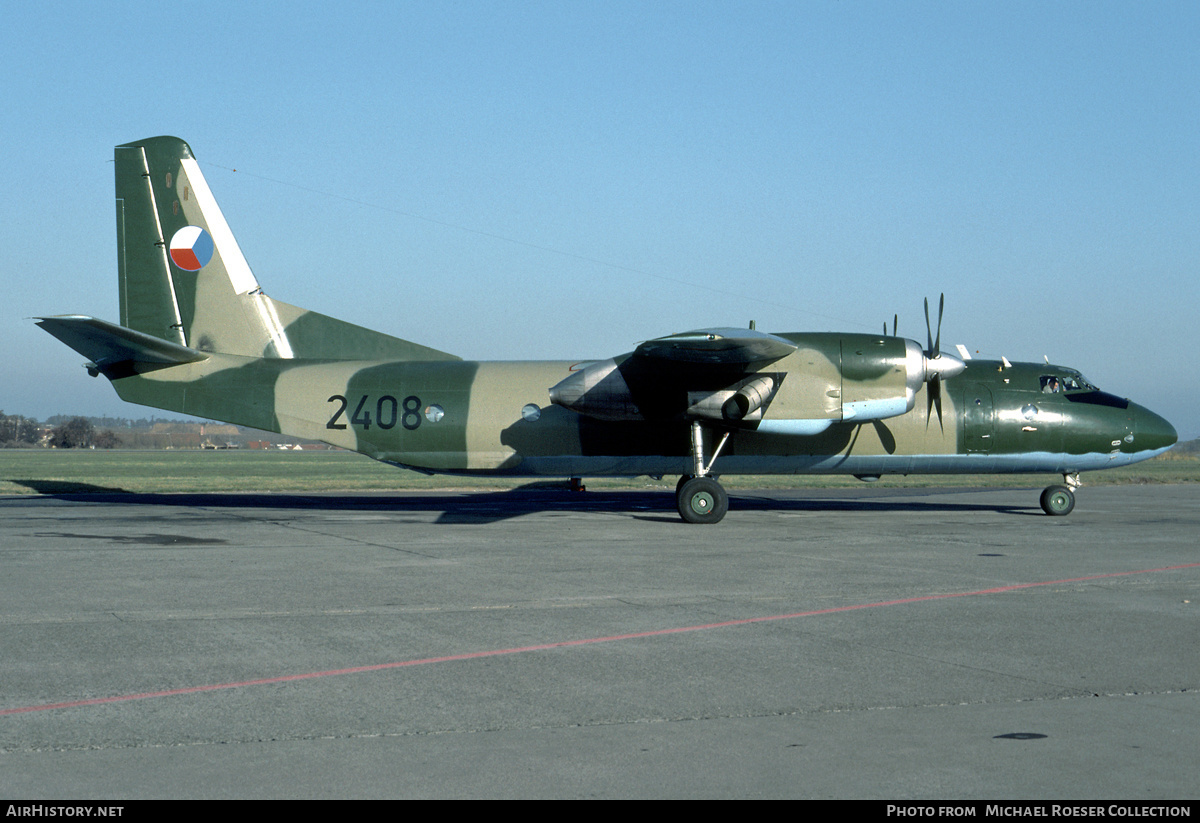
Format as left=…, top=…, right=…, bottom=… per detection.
left=0, top=449, right=1200, bottom=494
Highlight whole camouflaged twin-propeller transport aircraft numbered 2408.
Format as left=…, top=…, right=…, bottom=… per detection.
left=38, top=137, right=1176, bottom=523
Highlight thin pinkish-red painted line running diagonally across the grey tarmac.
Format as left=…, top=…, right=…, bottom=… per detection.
left=0, top=563, right=1200, bottom=715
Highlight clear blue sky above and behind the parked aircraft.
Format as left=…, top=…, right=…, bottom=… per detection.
left=0, top=0, right=1200, bottom=438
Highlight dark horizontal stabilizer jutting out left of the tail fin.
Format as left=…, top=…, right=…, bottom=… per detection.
left=35, top=314, right=208, bottom=374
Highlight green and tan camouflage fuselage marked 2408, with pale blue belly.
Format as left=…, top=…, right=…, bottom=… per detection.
left=103, top=335, right=1175, bottom=476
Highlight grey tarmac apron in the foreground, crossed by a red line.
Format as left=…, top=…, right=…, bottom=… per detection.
left=0, top=486, right=1200, bottom=801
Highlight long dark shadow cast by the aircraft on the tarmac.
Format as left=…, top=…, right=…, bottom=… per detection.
left=7, top=481, right=1042, bottom=527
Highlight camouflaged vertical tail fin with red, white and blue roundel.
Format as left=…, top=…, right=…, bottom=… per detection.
left=115, top=137, right=458, bottom=360
